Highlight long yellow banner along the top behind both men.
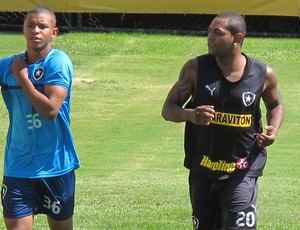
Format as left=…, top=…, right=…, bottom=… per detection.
left=0, top=0, right=300, bottom=16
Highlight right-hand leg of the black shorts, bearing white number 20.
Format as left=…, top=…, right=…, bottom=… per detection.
left=220, top=177, right=258, bottom=230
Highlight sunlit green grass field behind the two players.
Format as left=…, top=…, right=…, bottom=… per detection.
left=0, top=33, right=300, bottom=230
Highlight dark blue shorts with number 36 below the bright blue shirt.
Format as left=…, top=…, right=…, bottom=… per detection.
left=1, top=171, right=76, bottom=220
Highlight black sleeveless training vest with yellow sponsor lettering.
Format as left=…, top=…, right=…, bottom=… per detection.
left=184, top=54, right=267, bottom=179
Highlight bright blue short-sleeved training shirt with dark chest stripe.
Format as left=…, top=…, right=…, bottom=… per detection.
left=0, top=49, right=80, bottom=178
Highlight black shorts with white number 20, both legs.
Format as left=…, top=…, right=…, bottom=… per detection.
left=189, top=171, right=258, bottom=230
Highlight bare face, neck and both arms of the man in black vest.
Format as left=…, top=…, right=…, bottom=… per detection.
left=162, top=18, right=285, bottom=148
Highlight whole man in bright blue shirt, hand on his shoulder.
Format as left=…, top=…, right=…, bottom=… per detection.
left=0, top=7, right=80, bottom=230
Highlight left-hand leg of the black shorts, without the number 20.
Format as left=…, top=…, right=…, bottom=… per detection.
left=189, top=171, right=219, bottom=230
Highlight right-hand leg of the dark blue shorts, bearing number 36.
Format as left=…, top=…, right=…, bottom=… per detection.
left=38, top=171, right=75, bottom=221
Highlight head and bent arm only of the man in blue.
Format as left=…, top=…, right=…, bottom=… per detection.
left=11, top=13, right=67, bottom=120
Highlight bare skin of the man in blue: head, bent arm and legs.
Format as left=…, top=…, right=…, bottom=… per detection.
left=5, top=9, right=73, bottom=230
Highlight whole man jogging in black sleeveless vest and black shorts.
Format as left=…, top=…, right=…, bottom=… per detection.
left=162, top=12, right=285, bottom=230
